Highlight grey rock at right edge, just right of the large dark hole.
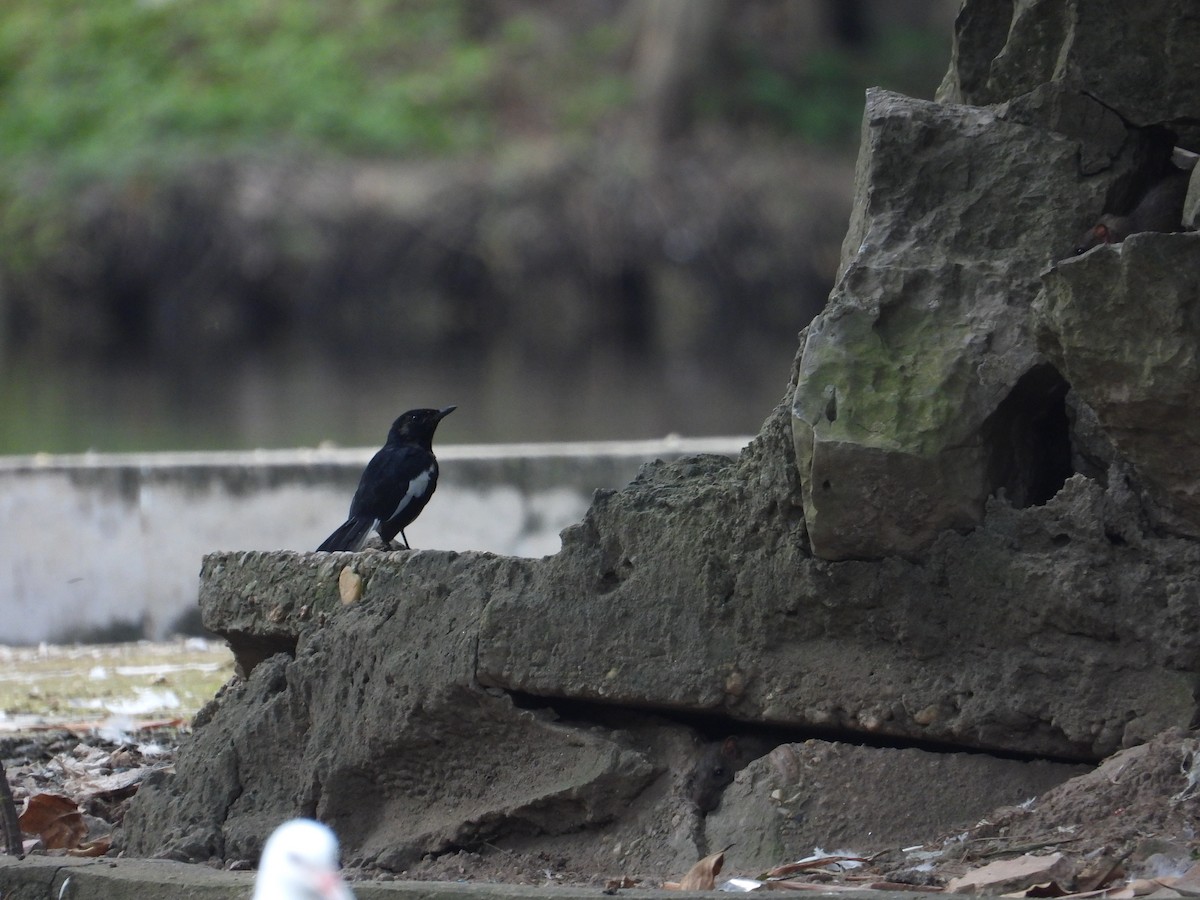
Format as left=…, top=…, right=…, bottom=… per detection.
left=1034, top=234, right=1200, bottom=538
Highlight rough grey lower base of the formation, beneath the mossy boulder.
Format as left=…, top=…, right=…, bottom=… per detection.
left=124, top=408, right=1200, bottom=871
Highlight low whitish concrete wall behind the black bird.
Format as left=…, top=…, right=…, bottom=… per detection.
left=0, top=438, right=749, bottom=644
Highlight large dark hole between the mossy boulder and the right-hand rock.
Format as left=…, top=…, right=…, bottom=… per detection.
left=983, top=365, right=1074, bottom=509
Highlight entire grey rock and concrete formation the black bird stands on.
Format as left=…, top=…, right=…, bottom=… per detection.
left=124, top=0, right=1200, bottom=888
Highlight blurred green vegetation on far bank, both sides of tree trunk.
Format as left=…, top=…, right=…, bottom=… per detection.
left=0, top=0, right=944, bottom=175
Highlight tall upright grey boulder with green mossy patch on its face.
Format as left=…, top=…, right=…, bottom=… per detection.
left=793, top=91, right=1094, bottom=559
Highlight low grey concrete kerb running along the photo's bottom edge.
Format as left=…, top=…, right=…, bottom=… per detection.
left=0, top=856, right=912, bottom=900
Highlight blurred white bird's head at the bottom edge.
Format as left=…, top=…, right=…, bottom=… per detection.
left=254, top=818, right=354, bottom=900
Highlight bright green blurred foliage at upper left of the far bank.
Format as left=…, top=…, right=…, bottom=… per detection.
left=0, top=0, right=623, bottom=172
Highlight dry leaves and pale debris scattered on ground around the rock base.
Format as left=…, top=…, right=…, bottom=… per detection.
left=0, top=646, right=1200, bottom=900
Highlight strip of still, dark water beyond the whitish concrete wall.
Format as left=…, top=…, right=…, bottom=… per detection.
left=0, top=343, right=796, bottom=454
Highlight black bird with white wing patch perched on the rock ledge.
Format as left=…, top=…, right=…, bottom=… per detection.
left=317, top=407, right=456, bottom=553
